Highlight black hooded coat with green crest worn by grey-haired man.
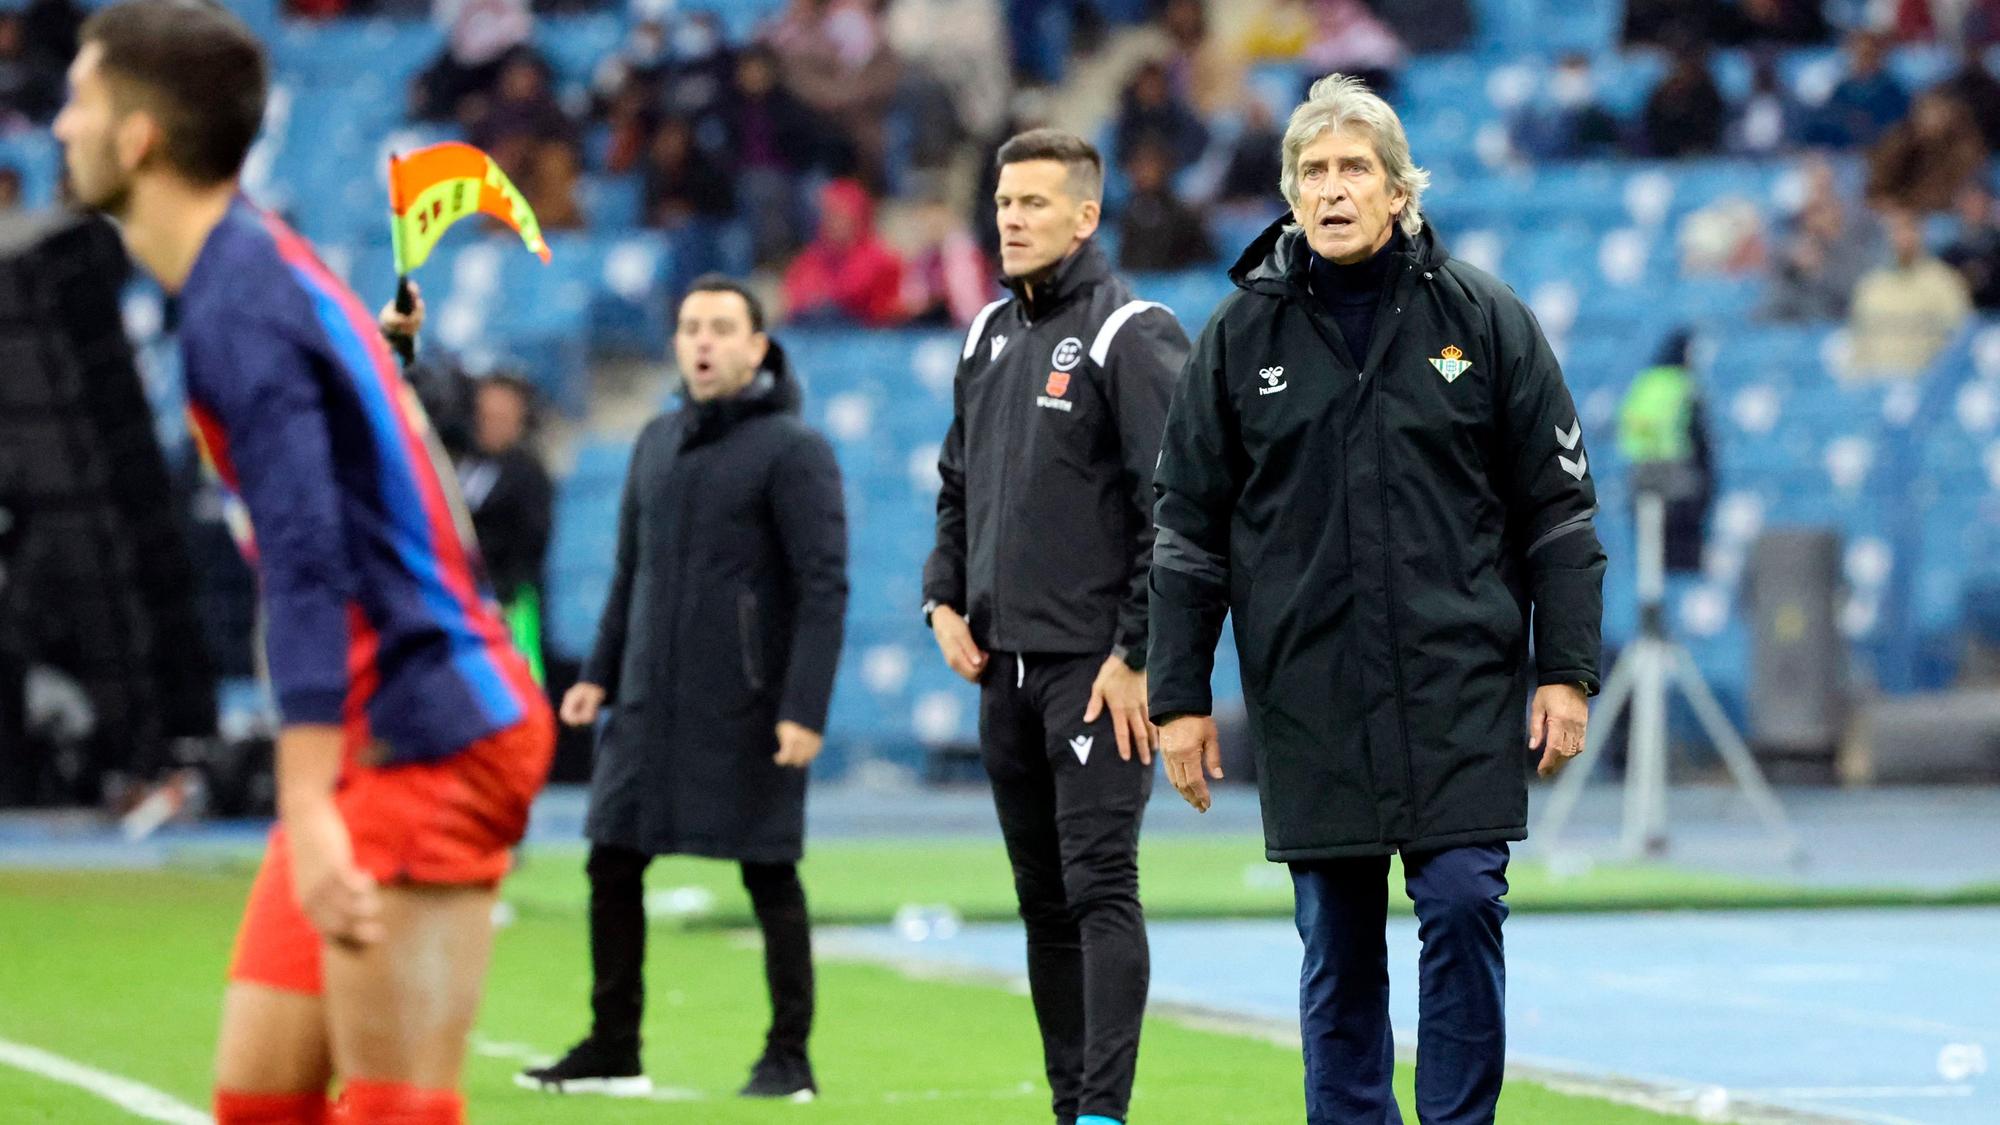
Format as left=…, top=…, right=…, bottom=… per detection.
left=1150, top=214, right=1604, bottom=861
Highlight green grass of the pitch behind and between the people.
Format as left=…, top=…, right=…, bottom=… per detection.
left=0, top=860, right=1686, bottom=1125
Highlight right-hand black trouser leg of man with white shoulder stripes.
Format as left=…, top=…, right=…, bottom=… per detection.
left=1028, top=657, right=1154, bottom=1125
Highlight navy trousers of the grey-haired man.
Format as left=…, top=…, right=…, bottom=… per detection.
left=1292, top=843, right=1508, bottom=1125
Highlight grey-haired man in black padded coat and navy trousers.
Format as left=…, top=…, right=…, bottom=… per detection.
left=1150, top=76, right=1604, bottom=1125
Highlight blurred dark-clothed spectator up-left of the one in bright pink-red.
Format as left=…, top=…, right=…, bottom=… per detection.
left=726, top=46, right=820, bottom=266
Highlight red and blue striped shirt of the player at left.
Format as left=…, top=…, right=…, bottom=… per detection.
left=180, top=200, right=538, bottom=763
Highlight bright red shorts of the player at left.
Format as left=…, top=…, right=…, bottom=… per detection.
left=230, top=707, right=556, bottom=995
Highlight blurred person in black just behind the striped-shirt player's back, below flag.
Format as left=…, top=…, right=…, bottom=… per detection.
left=458, top=374, right=556, bottom=683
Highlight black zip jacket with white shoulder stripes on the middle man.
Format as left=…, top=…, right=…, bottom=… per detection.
left=924, top=242, right=1188, bottom=665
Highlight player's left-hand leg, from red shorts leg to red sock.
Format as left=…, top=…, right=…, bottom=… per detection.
left=214, top=831, right=332, bottom=1125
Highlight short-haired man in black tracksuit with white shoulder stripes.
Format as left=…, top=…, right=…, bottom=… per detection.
left=924, top=130, right=1188, bottom=1125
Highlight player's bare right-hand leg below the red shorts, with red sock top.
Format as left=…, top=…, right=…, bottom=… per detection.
left=324, top=885, right=496, bottom=1125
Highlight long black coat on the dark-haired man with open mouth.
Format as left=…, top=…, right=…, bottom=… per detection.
left=584, top=342, right=848, bottom=863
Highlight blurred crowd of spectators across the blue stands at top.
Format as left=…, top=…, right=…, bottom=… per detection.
left=0, top=0, right=2000, bottom=360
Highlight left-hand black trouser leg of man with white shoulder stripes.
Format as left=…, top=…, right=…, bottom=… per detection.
left=980, top=653, right=1084, bottom=1121
